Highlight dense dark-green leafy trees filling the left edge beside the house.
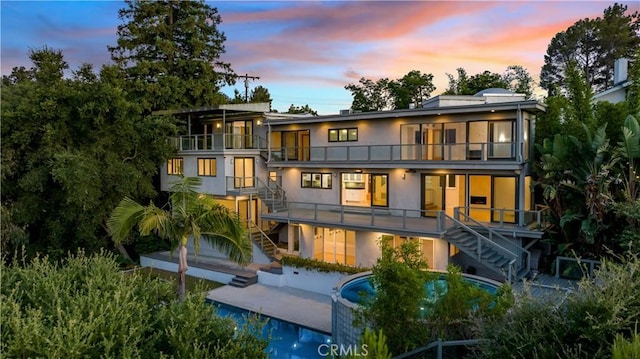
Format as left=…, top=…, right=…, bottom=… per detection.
left=1, top=47, right=175, bottom=258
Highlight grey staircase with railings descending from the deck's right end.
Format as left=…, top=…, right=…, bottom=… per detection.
left=444, top=213, right=530, bottom=283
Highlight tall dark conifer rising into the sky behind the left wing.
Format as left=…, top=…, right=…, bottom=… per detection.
left=109, top=0, right=236, bottom=112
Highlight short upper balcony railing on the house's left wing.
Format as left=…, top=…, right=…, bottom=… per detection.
left=170, top=133, right=267, bottom=151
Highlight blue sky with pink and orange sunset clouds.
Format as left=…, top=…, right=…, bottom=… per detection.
left=0, top=0, right=640, bottom=115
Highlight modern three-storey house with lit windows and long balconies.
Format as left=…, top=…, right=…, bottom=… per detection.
left=162, top=89, right=544, bottom=280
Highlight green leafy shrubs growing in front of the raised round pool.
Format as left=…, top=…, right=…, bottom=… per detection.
left=354, top=237, right=513, bottom=355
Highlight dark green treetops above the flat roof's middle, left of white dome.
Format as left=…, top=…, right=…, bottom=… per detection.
left=344, top=70, right=435, bottom=112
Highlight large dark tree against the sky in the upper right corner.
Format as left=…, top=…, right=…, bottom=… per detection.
left=540, top=3, right=640, bottom=95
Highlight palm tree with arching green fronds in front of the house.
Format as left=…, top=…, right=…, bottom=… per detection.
left=107, top=177, right=252, bottom=300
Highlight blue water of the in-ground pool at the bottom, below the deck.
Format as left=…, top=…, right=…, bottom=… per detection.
left=212, top=302, right=331, bottom=359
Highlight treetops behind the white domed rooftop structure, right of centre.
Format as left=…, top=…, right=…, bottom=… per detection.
left=443, top=65, right=535, bottom=98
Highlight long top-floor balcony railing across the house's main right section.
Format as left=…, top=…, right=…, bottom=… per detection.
left=271, top=142, right=517, bottom=161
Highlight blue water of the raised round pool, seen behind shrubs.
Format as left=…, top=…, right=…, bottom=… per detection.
left=340, top=276, right=498, bottom=304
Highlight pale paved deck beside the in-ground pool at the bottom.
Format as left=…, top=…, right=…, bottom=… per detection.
left=207, top=284, right=331, bottom=334
